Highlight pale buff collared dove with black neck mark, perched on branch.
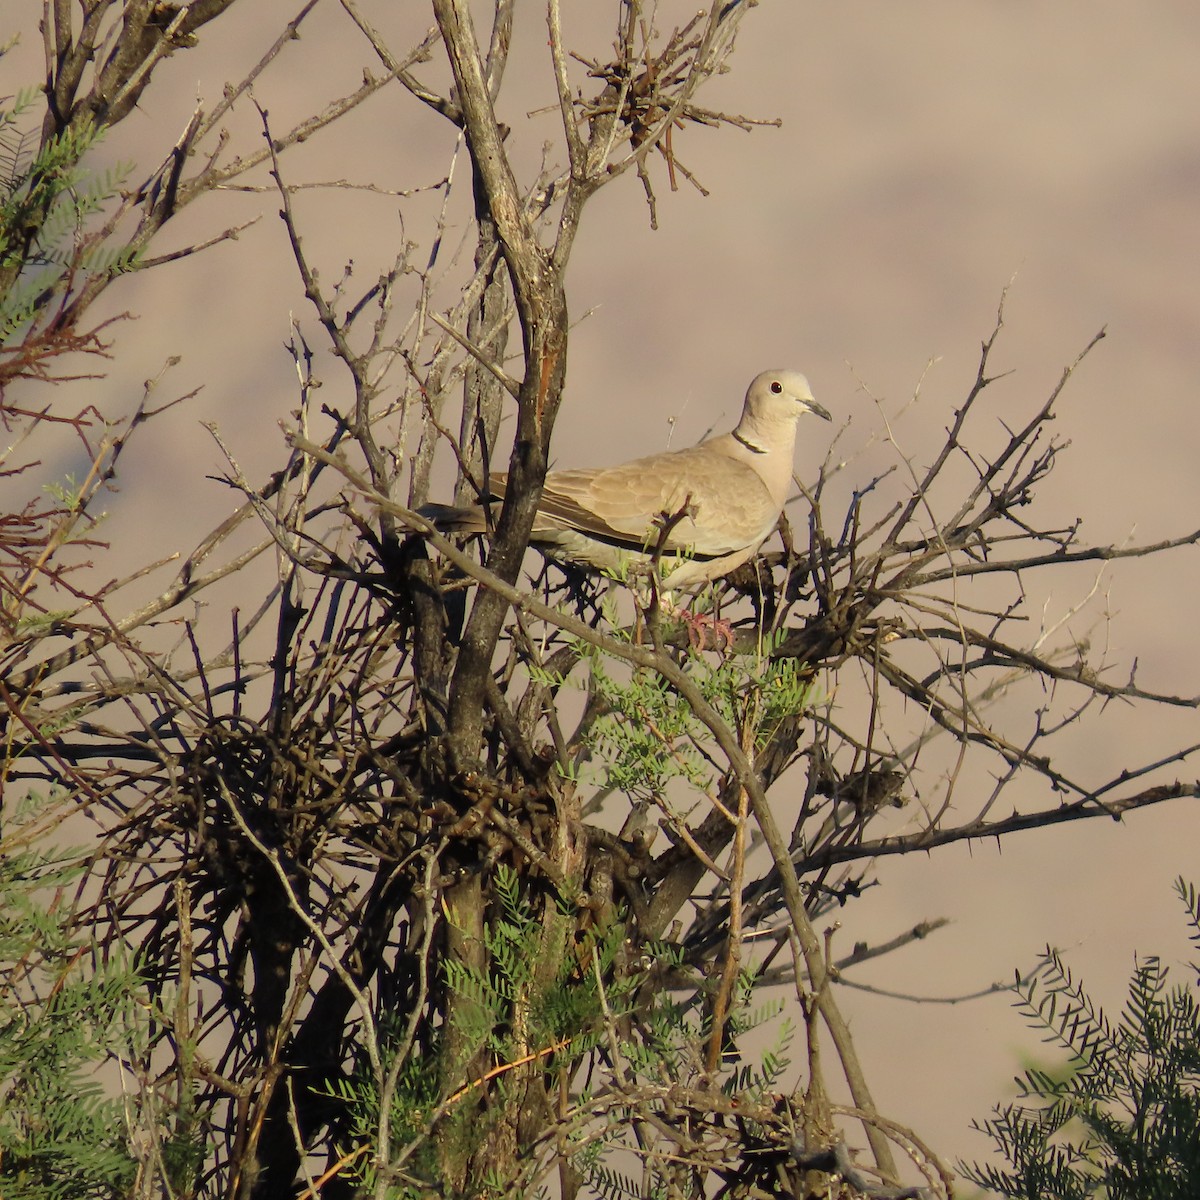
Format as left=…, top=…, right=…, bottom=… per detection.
left=421, top=371, right=830, bottom=589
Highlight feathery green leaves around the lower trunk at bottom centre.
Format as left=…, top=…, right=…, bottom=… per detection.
left=329, top=865, right=793, bottom=1200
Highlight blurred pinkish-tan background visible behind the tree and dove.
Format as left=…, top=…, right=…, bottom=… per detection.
left=0, top=0, right=1200, bottom=1176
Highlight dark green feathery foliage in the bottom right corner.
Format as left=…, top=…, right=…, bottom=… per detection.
left=964, top=880, right=1200, bottom=1200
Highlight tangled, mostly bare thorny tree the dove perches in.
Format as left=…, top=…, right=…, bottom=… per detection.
left=0, top=0, right=1200, bottom=1198
